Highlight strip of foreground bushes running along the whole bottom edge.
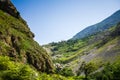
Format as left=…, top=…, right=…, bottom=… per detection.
left=0, top=56, right=120, bottom=80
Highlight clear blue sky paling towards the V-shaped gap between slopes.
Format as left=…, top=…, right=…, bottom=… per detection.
left=11, top=0, right=120, bottom=45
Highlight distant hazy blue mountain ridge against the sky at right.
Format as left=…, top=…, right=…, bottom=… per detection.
left=72, top=10, right=120, bottom=40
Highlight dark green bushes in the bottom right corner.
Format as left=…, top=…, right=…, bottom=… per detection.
left=90, top=61, right=120, bottom=80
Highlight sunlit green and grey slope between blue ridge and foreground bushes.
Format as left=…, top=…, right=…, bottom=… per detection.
left=44, top=23, right=120, bottom=74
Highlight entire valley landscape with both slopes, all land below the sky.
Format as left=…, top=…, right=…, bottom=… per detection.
left=0, top=0, right=120, bottom=80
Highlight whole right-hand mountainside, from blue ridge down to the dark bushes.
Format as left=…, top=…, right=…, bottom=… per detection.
left=43, top=10, right=120, bottom=80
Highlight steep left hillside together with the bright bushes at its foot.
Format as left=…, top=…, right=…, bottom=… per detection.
left=0, top=0, right=77, bottom=80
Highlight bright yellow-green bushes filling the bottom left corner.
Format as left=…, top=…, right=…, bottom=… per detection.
left=0, top=56, right=37, bottom=80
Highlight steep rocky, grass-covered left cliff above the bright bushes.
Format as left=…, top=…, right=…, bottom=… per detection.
left=0, top=0, right=53, bottom=73
